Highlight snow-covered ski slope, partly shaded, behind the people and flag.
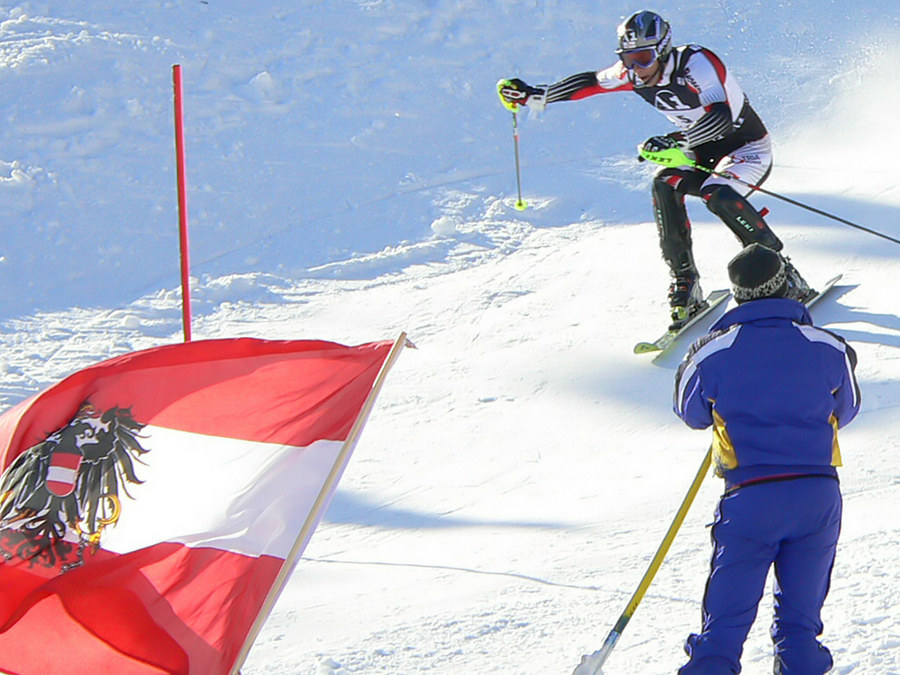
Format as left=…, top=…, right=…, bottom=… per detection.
left=0, top=0, right=900, bottom=675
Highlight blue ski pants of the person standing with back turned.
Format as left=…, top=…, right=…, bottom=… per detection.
left=678, top=476, right=842, bottom=675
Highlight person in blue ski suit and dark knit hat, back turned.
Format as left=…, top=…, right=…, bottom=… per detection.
left=674, top=244, right=860, bottom=675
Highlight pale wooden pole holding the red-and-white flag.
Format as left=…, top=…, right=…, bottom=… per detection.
left=229, top=332, right=412, bottom=675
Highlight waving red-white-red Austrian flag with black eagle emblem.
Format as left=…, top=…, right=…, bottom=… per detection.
left=0, top=335, right=406, bottom=675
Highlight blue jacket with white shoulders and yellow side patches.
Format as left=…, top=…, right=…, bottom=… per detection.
left=673, top=298, right=860, bottom=487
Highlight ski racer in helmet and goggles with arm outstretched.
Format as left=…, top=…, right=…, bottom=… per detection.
left=498, top=11, right=814, bottom=329
